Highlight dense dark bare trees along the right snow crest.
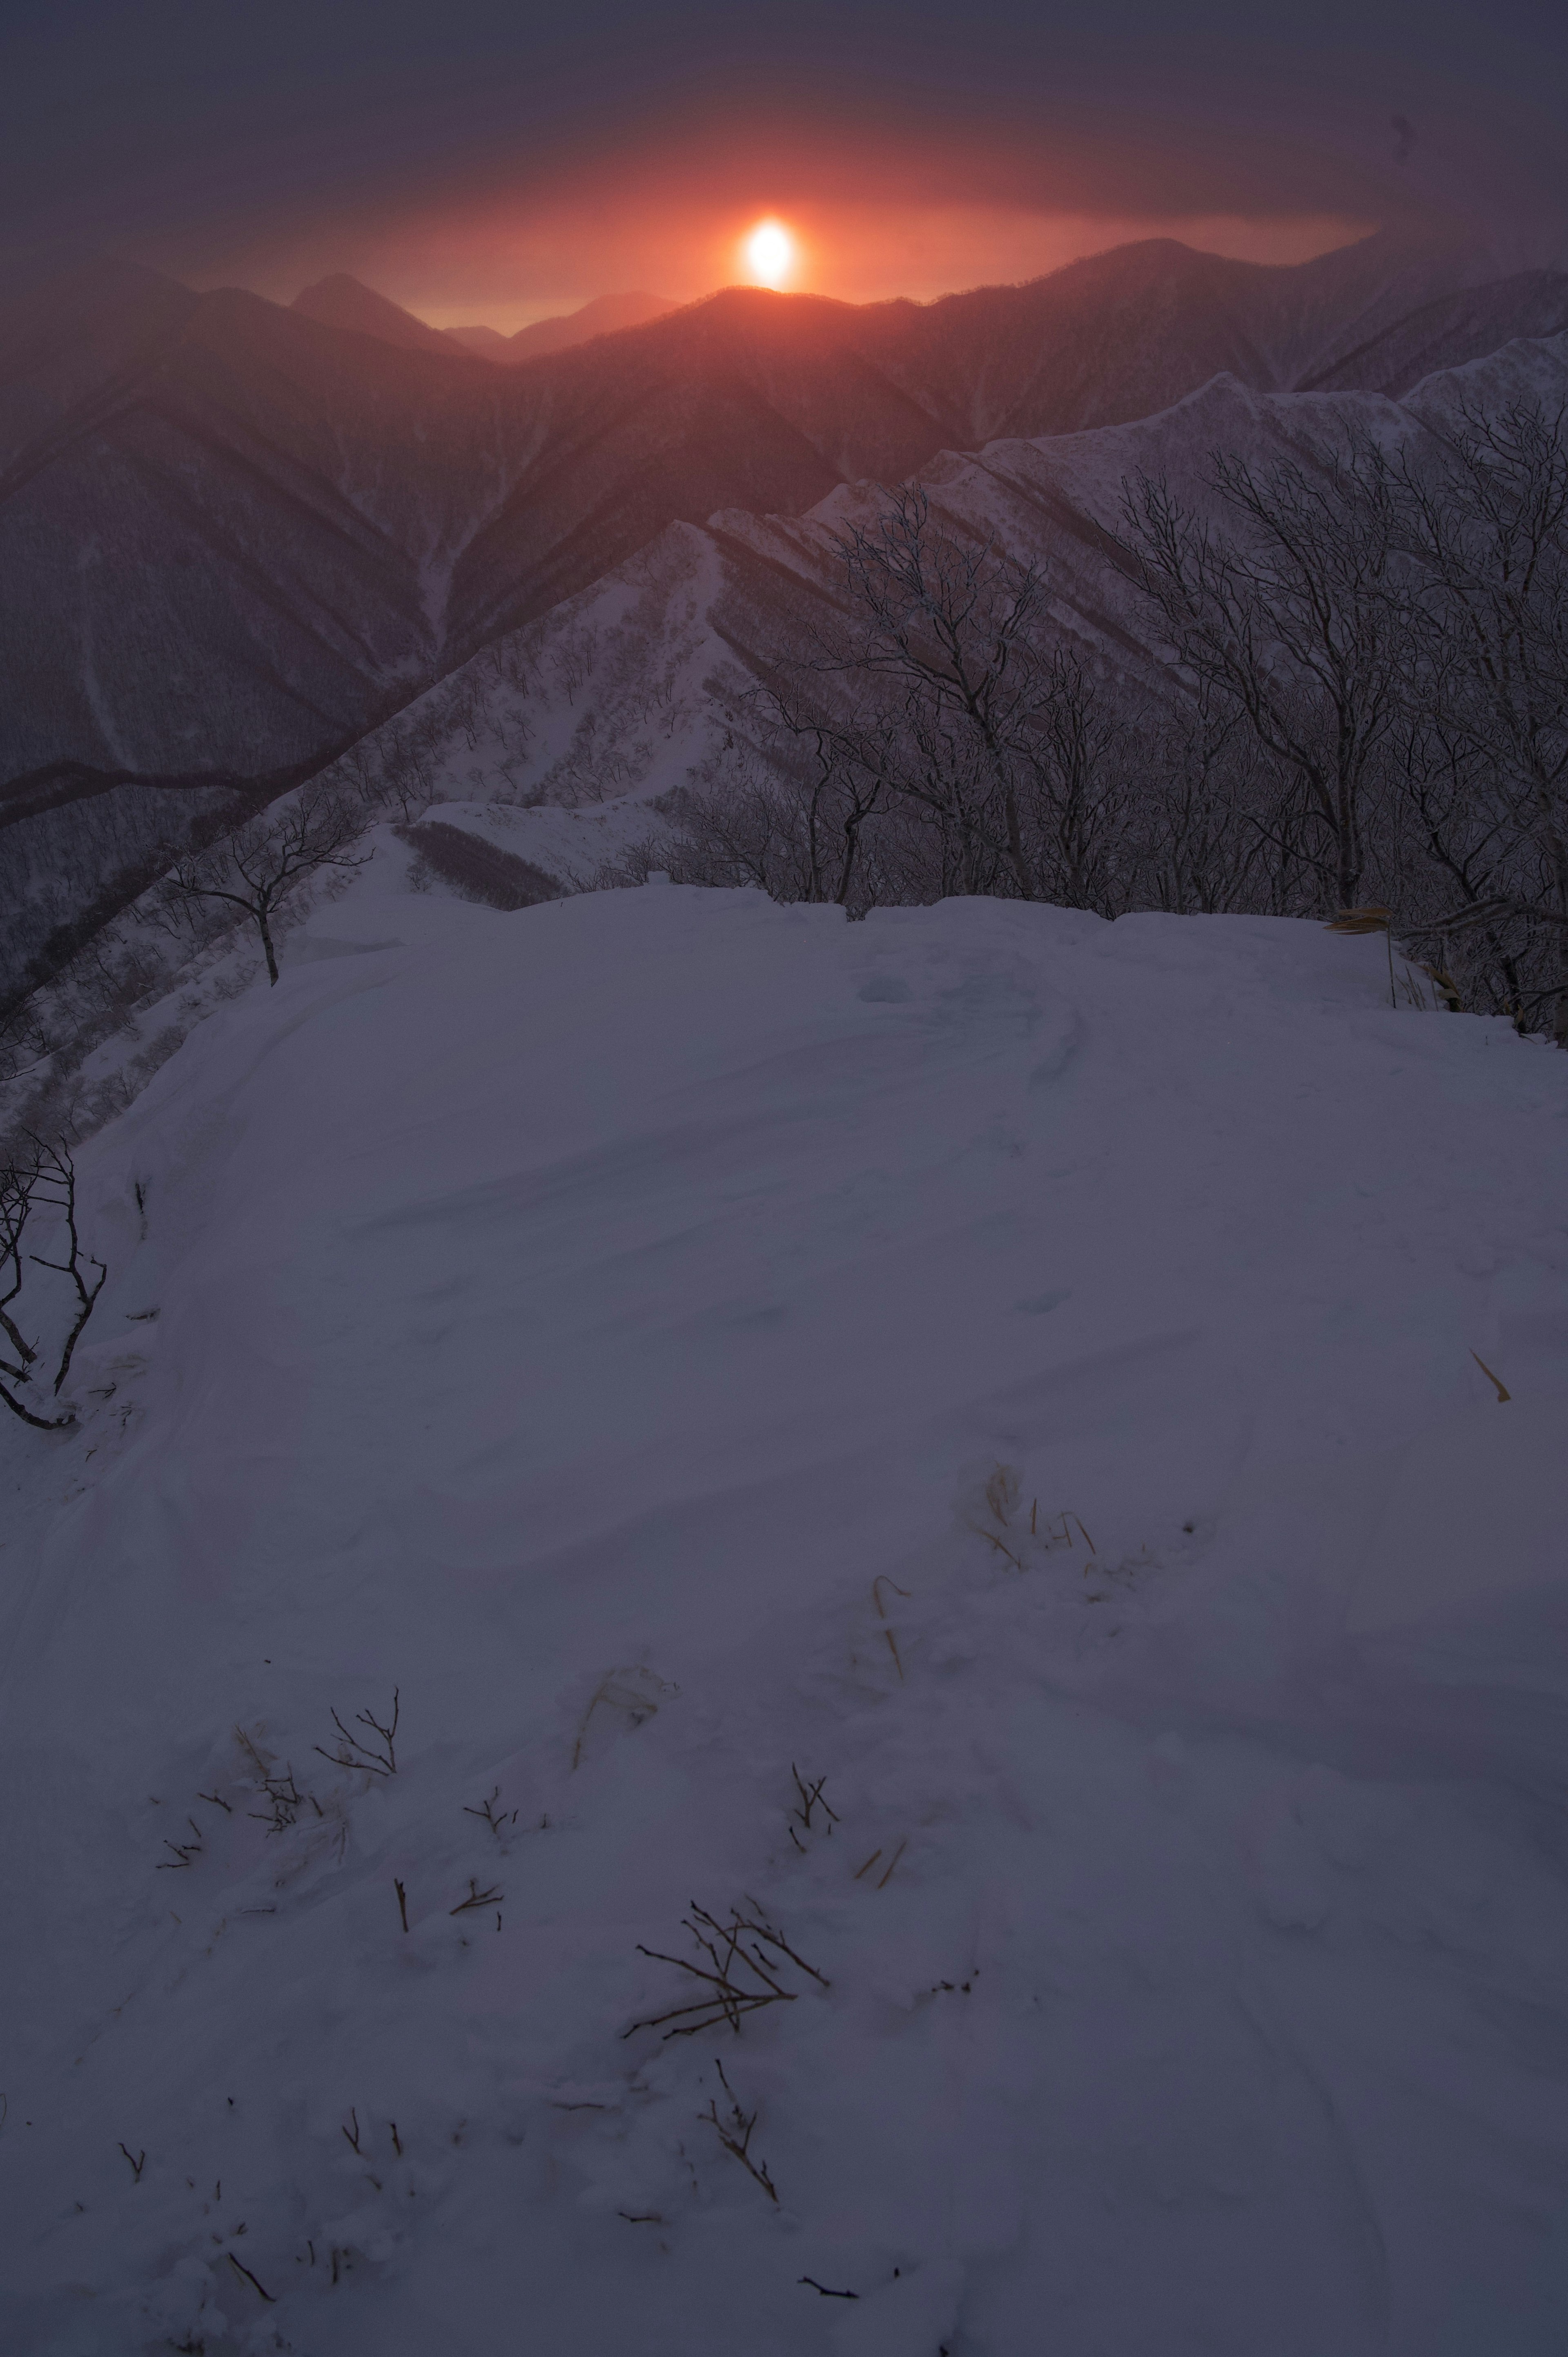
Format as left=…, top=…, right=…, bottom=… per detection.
left=620, top=403, right=1568, bottom=1039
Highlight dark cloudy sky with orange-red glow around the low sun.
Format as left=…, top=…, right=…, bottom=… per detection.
left=0, top=0, right=1568, bottom=330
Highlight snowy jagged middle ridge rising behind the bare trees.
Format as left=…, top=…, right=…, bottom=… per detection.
left=297, top=332, right=1568, bottom=853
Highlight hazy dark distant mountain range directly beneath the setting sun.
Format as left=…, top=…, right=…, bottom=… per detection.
left=0, top=238, right=1568, bottom=985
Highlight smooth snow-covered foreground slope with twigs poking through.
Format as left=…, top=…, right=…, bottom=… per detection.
left=0, top=863, right=1568, bottom=2357
